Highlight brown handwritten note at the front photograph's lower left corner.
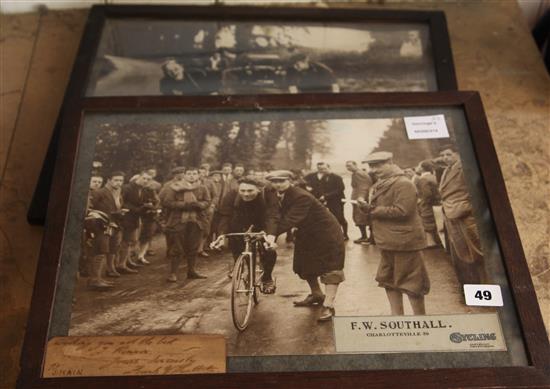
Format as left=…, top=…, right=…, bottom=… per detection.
left=43, top=335, right=226, bottom=377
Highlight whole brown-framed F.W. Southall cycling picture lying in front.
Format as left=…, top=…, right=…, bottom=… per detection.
left=19, top=92, right=550, bottom=388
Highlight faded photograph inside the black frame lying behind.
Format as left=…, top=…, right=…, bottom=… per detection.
left=87, top=19, right=438, bottom=96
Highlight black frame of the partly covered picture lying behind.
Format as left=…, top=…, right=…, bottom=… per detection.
left=27, top=5, right=457, bottom=224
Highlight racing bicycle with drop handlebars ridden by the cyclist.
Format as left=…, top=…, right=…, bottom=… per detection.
left=210, top=231, right=272, bottom=331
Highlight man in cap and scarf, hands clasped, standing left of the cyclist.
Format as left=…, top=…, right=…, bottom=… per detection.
left=161, top=167, right=211, bottom=282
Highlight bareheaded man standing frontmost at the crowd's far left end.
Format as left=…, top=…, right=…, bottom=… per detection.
left=85, top=171, right=128, bottom=290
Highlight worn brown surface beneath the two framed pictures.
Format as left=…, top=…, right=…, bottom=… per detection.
left=0, top=0, right=550, bottom=388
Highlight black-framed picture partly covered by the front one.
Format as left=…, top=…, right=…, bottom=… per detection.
left=28, top=5, right=457, bottom=223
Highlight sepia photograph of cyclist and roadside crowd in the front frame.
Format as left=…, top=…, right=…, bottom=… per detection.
left=48, top=104, right=536, bottom=371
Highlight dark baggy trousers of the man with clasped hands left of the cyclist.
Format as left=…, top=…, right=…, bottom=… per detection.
left=166, top=222, right=202, bottom=273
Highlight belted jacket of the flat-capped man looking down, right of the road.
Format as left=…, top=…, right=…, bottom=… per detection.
left=370, top=175, right=426, bottom=251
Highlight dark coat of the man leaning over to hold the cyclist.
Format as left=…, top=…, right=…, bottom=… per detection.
left=265, top=187, right=345, bottom=279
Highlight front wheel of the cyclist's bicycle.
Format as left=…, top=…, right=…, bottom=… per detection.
left=231, top=254, right=254, bottom=331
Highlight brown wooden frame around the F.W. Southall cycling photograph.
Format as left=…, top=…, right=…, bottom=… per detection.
left=18, top=92, right=550, bottom=389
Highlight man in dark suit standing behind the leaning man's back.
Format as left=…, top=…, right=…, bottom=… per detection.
left=304, top=162, right=349, bottom=240
